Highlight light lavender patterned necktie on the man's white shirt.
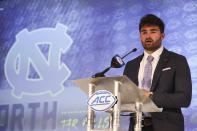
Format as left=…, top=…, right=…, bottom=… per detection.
left=142, top=55, right=154, bottom=91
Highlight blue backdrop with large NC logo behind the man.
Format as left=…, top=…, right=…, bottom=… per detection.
left=0, top=0, right=197, bottom=131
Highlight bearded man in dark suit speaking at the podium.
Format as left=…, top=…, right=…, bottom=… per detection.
left=124, top=14, right=192, bottom=131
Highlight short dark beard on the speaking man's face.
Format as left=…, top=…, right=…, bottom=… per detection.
left=142, top=37, right=161, bottom=52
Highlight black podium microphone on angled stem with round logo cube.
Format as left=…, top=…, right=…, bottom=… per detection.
left=92, top=48, right=137, bottom=78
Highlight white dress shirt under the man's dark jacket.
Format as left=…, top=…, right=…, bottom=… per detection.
left=138, top=46, right=163, bottom=89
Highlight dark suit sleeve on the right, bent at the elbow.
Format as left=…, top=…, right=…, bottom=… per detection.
left=152, top=57, right=192, bottom=108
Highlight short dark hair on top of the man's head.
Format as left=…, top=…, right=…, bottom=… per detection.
left=139, top=14, right=165, bottom=33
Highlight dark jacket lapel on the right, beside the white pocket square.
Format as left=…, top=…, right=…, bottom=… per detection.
left=150, top=48, right=169, bottom=91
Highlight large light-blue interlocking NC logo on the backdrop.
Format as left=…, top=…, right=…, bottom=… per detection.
left=4, top=23, right=73, bottom=98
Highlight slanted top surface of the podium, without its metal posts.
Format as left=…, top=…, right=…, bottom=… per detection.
left=72, top=76, right=161, bottom=112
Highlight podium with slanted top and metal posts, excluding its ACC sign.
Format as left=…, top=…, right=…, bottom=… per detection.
left=72, top=76, right=161, bottom=131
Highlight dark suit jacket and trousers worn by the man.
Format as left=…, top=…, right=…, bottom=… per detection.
left=124, top=48, right=192, bottom=131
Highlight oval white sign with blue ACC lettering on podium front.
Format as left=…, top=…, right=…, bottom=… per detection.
left=88, top=90, right=117, bottom=111
